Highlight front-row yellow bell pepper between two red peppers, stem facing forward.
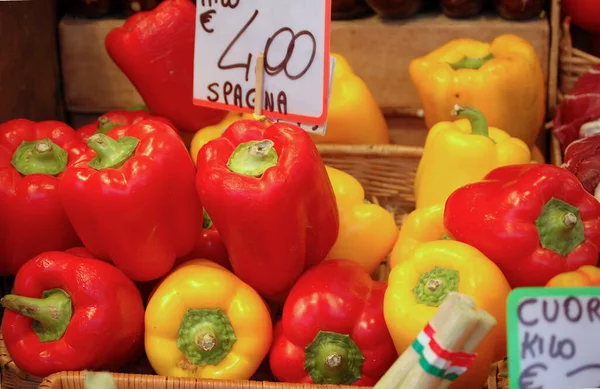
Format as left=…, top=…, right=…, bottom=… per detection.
left=145, top=260, right=273, bottom=380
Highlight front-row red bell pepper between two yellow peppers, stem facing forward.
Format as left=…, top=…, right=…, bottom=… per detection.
left=269, top=260, right=398, bottom=386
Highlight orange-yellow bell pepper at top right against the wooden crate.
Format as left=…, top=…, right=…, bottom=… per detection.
left=409, top=34, right=546, bottom=147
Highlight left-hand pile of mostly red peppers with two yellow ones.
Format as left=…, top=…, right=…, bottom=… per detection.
left=0, top=110, right=399, bottom=385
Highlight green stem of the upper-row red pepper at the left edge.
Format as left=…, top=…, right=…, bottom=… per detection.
left=11, top=139, right=69, bottom=176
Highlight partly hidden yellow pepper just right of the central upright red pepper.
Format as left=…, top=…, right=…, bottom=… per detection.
left=326, top=166, right=398, bottom=274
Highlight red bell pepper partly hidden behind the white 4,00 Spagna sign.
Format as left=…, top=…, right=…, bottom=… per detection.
left=105, top=0, right=227, bottom=132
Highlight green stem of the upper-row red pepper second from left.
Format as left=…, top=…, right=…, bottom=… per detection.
left=88, top=134, right=140, bottom=170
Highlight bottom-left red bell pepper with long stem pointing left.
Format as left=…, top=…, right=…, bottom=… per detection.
left=0, top=251, right=144, bottom=377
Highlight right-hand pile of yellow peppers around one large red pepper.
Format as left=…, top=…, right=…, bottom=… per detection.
left=384, top=102, right=600, bottom=388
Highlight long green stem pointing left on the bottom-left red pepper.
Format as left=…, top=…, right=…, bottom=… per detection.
left=0, top=289, right=73, bottom=342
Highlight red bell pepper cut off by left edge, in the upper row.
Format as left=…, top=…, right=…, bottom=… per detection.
left=0, top=119, right=86, bottom=275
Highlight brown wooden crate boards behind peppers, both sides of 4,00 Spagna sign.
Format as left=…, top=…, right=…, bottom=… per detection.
left=59, top=12, right=557, bottom=115
